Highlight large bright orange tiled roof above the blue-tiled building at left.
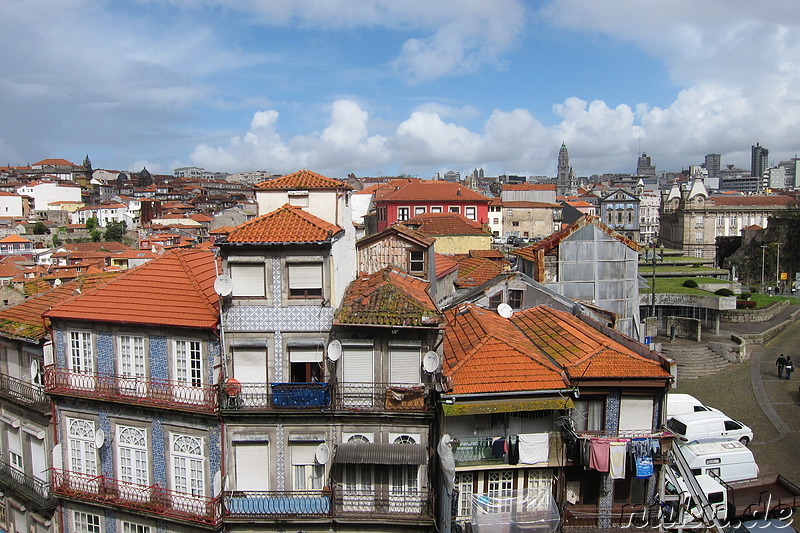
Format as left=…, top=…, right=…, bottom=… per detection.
left=45, top=250, right=219, bottom=329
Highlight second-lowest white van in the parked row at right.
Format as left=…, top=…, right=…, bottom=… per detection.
left=680, top=440, right=758, bottom=483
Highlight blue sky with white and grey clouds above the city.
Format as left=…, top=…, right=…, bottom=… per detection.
left=0, top=0, right=800, bottom=177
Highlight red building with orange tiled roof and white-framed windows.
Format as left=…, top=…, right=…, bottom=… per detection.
left=373, top=178, right=491, bottom=232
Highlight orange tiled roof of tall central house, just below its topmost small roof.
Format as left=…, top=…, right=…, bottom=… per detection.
left=226, top=204, right=344, bottom=244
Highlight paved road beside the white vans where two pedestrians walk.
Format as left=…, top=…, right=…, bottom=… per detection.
left=676, top=322, right=800, bottom=485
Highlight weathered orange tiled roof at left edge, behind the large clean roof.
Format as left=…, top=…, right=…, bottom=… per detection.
left=0, top=274, right=121, bottom=340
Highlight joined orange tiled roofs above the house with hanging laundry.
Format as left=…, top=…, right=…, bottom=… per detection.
left=443, top=304, right=670, bottom=394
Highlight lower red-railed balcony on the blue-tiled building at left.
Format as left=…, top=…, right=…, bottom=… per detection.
left=53, top=469, right=222, bottom=526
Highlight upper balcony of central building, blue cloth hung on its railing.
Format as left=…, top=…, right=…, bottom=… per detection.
left=219, top=383, right=433, bottom=413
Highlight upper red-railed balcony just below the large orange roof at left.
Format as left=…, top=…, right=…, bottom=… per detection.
left=44, top=365, right=217, bottom=413
